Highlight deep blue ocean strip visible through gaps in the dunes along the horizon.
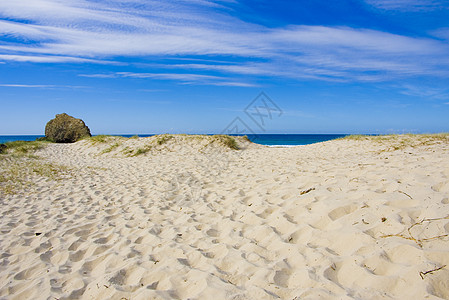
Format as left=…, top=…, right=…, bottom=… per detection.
left=0, top=134, right=346, bottom=147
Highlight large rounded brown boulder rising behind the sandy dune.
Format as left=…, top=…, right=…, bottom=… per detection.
left=45, top=113, right=92, bottom=143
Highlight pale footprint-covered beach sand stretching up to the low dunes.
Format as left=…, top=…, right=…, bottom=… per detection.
left=0, top=136, right=449, bottom=299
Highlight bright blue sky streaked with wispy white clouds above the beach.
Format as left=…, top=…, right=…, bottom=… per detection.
left=0, top=0, right=449, bottom=135
